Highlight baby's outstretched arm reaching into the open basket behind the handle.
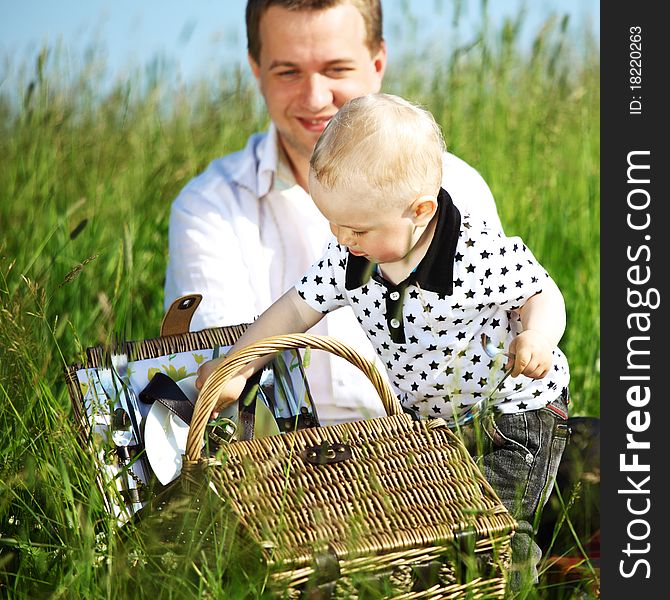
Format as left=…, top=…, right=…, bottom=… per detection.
left=195, top=288, right=324, bottom=410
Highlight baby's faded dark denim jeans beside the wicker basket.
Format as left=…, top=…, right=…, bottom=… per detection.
left=459, top=388, right=569, bottom=590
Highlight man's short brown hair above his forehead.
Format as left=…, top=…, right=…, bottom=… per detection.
left=246, top=0, right=384, bottom=64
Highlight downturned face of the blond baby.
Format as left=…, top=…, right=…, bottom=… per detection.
left=309, top=176, right=414, bottom=264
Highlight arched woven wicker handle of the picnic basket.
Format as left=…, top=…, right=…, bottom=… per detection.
left=186, top=333, right=402, bottom=462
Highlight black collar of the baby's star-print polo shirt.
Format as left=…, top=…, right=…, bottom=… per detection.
left=345, top=188, right=461, bottom=296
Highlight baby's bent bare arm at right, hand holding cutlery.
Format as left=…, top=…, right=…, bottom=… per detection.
left=507, top=278, right=565, bottom=379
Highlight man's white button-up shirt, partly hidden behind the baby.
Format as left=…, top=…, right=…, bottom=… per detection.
left=165, top=125, right=501, bottom=424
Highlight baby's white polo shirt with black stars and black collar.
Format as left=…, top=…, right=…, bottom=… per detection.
left=296, top=189, right=570, bottom=421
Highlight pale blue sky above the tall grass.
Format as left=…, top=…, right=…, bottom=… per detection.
left=0, top=0, right=600, bottom=85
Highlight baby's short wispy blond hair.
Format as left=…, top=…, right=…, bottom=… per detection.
left=310, top=94, right=445, bottom=206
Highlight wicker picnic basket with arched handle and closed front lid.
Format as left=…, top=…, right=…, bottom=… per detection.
left=185, top=335, right=515, bottom=599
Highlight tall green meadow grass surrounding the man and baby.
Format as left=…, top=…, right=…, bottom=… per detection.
left=0, top=9, right=600, bottom=598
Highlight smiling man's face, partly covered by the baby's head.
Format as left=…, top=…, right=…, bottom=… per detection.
left=249, top=4, right=386, bottom=160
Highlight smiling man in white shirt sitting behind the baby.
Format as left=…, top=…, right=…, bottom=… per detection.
left=165, top=0, right=500, bottom=424
